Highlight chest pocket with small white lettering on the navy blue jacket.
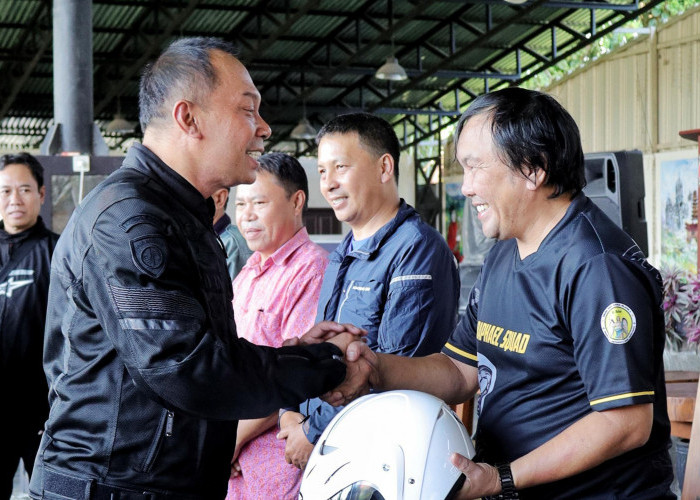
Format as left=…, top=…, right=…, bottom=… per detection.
left=335, top=280, right=385, bottom=334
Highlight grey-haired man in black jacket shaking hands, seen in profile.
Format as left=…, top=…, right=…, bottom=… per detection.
left=30, top=38, right=358, bottom=500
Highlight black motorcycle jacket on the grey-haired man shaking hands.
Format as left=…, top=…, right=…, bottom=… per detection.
left=30, top=145, right=345, bottom=500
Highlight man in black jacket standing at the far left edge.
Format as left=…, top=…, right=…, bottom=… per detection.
left=0, top=153, right=58, bottom=500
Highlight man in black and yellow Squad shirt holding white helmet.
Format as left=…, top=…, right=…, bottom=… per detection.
left=336, top=88, right=675, bottom=499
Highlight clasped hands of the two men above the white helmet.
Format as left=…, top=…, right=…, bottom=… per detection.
left=284, top=321, right=380, bottom=406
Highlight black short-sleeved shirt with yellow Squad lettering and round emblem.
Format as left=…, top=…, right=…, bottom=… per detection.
left=442, top=195, right=673, bottom=498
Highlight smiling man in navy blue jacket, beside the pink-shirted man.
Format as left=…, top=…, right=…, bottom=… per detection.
left=278, top=113, right=459, bottom=468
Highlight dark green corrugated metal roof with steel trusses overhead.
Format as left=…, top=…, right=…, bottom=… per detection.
left=0, top=0, right=662, bottom=150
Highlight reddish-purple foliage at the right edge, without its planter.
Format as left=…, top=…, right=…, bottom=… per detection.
left=661, top=269, right=700, bottom=351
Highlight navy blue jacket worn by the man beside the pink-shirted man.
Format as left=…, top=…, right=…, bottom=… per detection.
left=301, top=200, right=460, bottom=443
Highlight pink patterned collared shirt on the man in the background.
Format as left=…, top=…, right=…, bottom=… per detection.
left=226, top=228, right=328, bottom=500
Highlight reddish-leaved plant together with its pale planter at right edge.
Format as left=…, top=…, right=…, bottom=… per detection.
left=661, top=269, right=700, bottom=371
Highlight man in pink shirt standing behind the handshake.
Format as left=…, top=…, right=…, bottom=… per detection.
left=226, top=153, right=328, bottom=500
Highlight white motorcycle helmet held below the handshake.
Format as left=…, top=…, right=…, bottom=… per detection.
left=299, top=391, right=474, bottom=500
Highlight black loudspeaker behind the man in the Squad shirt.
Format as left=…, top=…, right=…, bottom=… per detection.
left=583, top=150, right=649, bottom=256
